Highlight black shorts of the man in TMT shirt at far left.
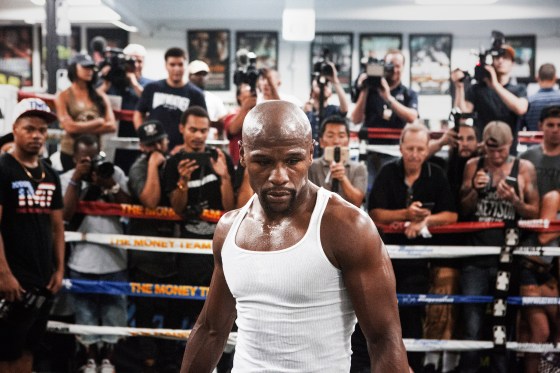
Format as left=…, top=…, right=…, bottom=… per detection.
left=0, top=294, right=52, bottom=361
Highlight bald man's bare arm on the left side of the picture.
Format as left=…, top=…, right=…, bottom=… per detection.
left=181, top=212, right=237, bottom=373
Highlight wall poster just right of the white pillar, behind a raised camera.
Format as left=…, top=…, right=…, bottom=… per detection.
left=310, top=32, right=353, bottom=92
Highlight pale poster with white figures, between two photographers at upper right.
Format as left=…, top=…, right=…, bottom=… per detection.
left=409, top=34, right=452, bottom=95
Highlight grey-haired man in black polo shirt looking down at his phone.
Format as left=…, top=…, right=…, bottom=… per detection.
left=352, top=124, right=457, bottom=371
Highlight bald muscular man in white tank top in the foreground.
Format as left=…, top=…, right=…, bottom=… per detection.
left=181, top=101, right=408, bottom=373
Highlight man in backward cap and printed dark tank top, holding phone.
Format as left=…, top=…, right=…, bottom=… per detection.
left=461, top=121, right=539, bottom=372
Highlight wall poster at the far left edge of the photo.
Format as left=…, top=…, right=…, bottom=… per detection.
left=0, top=26, right=33, bottom=86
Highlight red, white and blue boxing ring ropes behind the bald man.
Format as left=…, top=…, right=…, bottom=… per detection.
left=48, top=202, right=560, bottom=353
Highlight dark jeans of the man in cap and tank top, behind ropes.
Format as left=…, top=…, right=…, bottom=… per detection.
left=459, top=264, right=507, bottom=373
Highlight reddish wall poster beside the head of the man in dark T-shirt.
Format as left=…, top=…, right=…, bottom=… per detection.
left=187, top=30, right=230, bottom=91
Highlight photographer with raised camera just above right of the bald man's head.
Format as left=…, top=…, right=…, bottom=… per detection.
left=303, top=61, right=348, bottom=156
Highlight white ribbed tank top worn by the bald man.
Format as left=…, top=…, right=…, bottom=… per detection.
left=222, top=188, right=356, bottom=373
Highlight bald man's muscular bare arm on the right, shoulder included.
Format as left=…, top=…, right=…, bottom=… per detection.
left=321, top=201, right=409, bottom=373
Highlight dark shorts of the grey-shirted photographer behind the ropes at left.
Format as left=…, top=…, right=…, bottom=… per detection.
left=69, top=270, right=127, bottom=346
